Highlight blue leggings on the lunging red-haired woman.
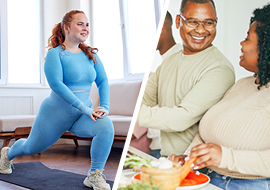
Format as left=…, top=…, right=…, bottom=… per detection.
left=7, top=92, right=114, bottom=172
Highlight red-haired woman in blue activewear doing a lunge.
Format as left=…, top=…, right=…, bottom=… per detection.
left=0, top=11, right=114, bottom=190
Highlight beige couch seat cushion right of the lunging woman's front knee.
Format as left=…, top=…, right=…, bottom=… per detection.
left=109, top=115, right=132, bottom=136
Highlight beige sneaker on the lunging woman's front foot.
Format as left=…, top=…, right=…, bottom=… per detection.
left=83, top=169, right=111, bottom=190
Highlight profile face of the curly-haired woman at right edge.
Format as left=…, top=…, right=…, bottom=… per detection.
left=239, top=21, right=259, bottom=73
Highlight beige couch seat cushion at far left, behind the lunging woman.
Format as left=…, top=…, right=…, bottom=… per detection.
left=0, top=115, right=36, bottom=132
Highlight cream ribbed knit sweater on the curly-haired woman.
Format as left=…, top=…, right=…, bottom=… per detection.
left=189, top=77, right=270, bottom=179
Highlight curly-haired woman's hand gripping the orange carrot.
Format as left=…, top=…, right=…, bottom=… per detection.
left=190, top=143, right=222, bottom=169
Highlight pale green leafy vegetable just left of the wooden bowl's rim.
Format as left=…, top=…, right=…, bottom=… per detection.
left=124, top=154, right=154, bottom=168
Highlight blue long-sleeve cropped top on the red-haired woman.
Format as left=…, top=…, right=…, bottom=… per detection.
left=44, top=46, right=110, bottom=116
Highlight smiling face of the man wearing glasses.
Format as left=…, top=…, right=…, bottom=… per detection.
left=176, top=1, right=217, bottom=55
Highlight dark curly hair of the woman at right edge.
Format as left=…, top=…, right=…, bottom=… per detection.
left=250, top=4, right=270, bottom=89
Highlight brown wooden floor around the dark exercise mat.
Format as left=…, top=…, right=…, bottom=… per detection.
left=0, top=144, right=123, bottom=190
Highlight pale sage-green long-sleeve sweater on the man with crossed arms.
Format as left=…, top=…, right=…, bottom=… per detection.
left=137, top=46, right=235, bottom=156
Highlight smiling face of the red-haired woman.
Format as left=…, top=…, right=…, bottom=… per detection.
left=64, top=13, right=89, bottom=43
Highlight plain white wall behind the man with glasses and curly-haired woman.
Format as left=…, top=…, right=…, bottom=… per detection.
left=168, top=0, right=270, bottom=80
